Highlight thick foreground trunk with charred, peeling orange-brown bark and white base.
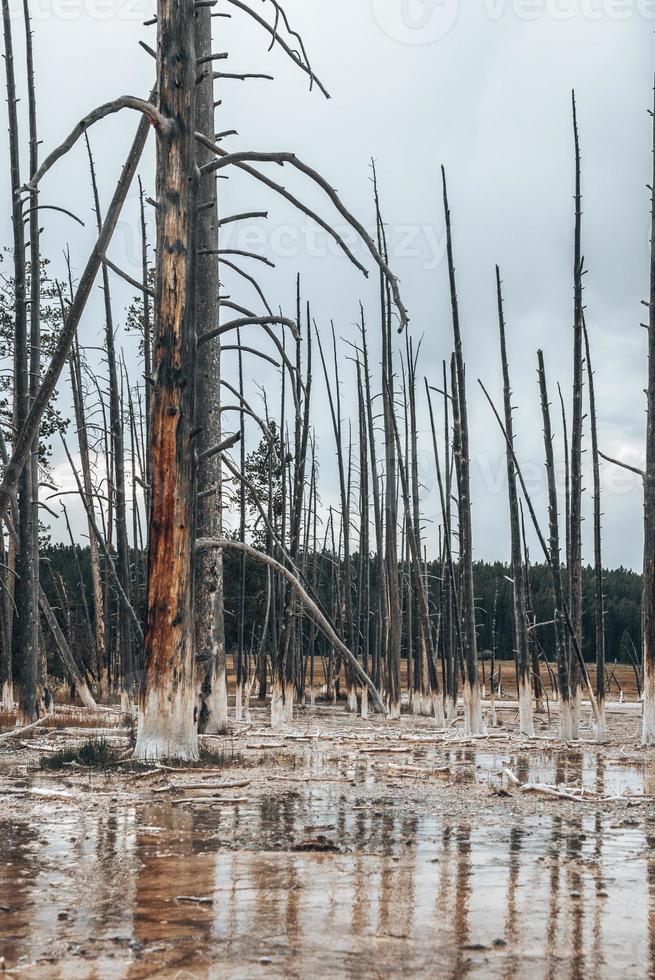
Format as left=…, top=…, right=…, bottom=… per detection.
left=135, top=0, right=198, bottom=759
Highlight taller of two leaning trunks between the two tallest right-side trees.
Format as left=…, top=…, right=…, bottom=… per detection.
left=496, top=266, right=534, bottom=737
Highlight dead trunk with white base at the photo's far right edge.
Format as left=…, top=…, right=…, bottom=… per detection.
left=642, top=78, right=655, bottom=745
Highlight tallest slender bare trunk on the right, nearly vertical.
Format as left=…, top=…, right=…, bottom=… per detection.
left=569, top=93, right=584, bottom=738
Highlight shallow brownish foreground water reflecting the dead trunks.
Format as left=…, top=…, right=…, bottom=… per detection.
left=0, top=751, right=655, bottom=980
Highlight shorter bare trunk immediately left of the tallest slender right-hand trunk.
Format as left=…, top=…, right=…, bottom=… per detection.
left=538, top=351, right=573, bottom=741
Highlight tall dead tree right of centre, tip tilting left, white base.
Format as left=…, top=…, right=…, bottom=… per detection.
left=441, top=167, right=484, bottom=735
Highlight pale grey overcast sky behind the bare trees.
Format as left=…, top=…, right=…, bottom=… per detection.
left=0, top=0, right=655, bottom=568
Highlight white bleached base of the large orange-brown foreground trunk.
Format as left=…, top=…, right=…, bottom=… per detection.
left=134, top=688, right=198, bottom=762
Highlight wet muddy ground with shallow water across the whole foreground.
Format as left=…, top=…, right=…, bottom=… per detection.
left=0, top=708, right=655, bottom=980
